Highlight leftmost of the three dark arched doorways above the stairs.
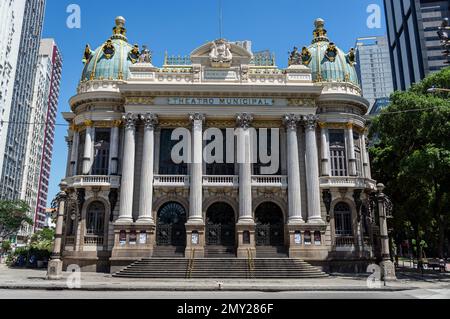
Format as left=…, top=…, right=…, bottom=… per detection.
left=156, top=202, right=187, bottom=247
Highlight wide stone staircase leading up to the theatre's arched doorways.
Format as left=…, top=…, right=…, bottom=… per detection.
left=113, top=258, right=328, bottom=279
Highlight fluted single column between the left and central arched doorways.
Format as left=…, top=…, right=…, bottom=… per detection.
left=188, top=113, right=205, bottom=224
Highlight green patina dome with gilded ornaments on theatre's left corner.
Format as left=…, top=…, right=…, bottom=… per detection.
left=81, top=17, right=139, bottom=81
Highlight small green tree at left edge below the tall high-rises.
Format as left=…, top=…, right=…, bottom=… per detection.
left=0, top=201, right=33, bottom=244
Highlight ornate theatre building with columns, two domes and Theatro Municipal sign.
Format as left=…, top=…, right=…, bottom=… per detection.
left=61, top=17, right=376, bottom=272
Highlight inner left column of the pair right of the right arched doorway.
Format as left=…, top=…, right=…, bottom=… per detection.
left=283, top=114, right=304, bottom=224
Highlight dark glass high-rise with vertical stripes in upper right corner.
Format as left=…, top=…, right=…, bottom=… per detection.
left=384, top=0, right=450, bottom=90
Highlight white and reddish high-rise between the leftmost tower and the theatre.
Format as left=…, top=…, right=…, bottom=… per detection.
left=21, top=39, right=62, bottom=233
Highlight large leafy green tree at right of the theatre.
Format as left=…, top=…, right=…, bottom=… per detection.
left=370, top=68, right=450, bottom=258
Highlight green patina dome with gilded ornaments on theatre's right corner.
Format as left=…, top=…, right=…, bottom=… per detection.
left=290, top=19, right=359, bottom=85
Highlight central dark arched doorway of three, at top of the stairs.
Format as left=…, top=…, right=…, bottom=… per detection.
left=206, top=202, right=236, bottom=247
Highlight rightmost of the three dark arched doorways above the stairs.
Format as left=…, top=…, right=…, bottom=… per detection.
left=255, top=202, right=284, bottom=247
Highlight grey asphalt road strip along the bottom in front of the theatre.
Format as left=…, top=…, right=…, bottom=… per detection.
left=0, top=289, right=450, bottom=300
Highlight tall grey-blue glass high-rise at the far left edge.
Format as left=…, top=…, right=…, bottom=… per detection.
left=0, top=0, right=46, bottom=200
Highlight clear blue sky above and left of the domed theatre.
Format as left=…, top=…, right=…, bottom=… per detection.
left=43, top=0, right=386, bottom=202
